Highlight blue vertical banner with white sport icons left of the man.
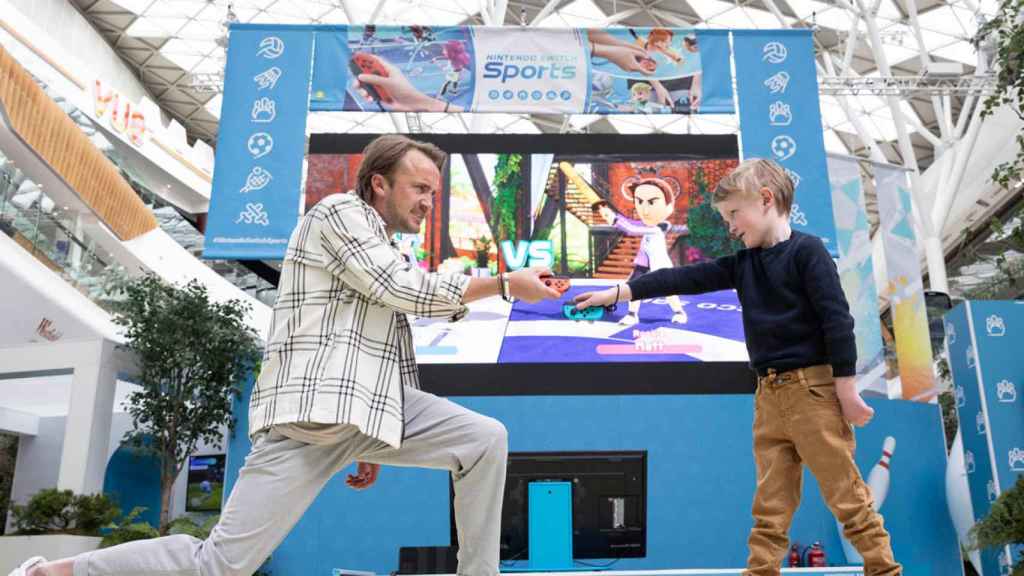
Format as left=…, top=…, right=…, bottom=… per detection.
left=203, top=25, right=313, bottom=259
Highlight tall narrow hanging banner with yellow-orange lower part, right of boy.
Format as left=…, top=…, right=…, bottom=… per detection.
left=874, top=166, right=937, bottom=402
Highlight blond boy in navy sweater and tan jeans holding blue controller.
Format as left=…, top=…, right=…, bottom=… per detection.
left=575, top=159, right=902, bottom=576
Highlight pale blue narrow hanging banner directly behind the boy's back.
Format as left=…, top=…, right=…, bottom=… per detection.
left=828, top=156, right=889, bottom=397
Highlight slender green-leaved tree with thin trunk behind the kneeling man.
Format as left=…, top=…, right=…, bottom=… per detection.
left=115, top=276, right=260, bottom=533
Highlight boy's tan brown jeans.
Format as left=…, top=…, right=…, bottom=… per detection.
left=743, top=366, right=902, bottom=576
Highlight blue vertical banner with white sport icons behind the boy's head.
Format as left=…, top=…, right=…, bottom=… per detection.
left=732, top=30, right=839, bottom=252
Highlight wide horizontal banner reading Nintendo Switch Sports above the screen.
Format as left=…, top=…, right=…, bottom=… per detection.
left=310, top=25, right=733, bottom=114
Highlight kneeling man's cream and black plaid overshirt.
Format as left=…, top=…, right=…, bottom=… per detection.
left=249, top=194, right=469, bottom=447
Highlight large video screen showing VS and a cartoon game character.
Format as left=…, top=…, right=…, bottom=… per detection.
left=306, top=134, right=749, bottom=393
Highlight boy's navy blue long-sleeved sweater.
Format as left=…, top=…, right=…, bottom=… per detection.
left=629, top=231, right=857, bottom=376
